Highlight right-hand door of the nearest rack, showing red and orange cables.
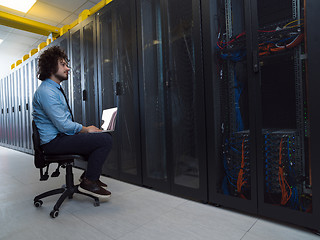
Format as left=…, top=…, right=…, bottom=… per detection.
left=256, top=0, right=319, bottom=227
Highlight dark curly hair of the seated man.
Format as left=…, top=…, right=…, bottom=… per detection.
left=38, top=46, right=69, bottom=81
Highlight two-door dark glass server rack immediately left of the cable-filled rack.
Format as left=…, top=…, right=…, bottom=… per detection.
left=137, top=0, right=207, bottom=201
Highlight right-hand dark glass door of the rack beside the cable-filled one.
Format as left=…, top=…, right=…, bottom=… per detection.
left=164, top=0, right=207, bottom=200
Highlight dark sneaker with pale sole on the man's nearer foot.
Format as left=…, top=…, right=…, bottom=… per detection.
left=78, top=178, right=111, bottom=201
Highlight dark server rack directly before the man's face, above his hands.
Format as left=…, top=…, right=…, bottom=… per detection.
left=70, top=16, right=98, bottom=126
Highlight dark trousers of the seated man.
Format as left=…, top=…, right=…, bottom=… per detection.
left=42, top=133, right=112, bottom=181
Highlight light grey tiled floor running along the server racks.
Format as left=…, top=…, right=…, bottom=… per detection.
left=0, top=147, right=320, bottom=240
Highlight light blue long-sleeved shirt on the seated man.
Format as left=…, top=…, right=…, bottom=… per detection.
left=32, top=79, right=82, bottom=145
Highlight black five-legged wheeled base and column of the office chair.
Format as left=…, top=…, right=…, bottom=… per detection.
left=33, top=163, right=100, bottom=218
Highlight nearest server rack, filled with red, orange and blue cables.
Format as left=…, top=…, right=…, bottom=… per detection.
left=203, top=0, right=320, bottom=229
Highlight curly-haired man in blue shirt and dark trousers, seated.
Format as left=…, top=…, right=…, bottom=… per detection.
left=32, top=46, right=112, bottom=200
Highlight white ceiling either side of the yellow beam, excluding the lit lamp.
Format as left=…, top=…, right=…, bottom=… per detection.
left=0, top=0, right=100, bottom=78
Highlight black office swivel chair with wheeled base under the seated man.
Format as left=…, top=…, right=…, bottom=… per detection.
left=32, top=121, right=100, bottom=218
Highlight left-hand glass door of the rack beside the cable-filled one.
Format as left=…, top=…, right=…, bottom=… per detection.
left=138, top=0, right=169, bottom=191
